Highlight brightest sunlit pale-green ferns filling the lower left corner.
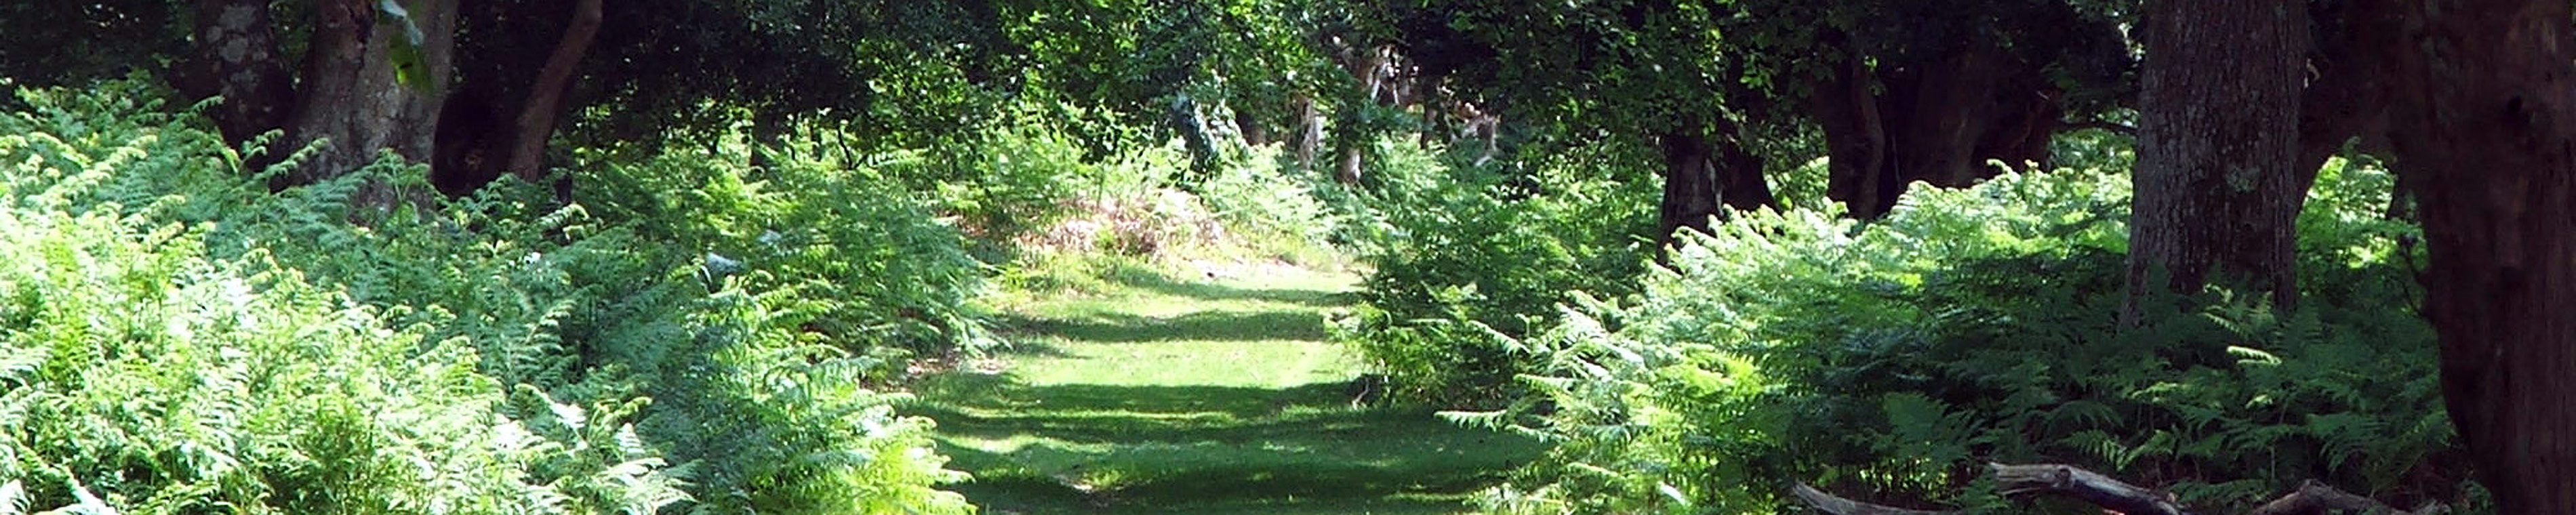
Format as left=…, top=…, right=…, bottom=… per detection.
left=0, top=93, right=685, bottom=512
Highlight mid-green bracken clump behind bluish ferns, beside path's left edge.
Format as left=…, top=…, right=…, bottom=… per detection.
left=595, top=132, right=994, bottom=366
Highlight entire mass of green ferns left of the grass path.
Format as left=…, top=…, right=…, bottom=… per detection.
left=0, top=83, right=982, bottom=512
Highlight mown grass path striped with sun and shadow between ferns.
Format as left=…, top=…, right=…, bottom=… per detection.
left=920, top=268, right=1538, bottom=515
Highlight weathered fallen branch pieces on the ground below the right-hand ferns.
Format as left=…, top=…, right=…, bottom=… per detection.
left=1790, top=464, right=2442, bottom=515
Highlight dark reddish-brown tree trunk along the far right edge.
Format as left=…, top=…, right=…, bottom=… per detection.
left=2357, top=0, right=2576, bottom=512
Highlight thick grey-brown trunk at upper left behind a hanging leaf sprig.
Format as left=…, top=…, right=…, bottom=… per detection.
left=286, top=0, right=456, bottom=183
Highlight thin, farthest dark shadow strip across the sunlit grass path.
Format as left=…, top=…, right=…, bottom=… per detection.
left=999, top=312, right=1327, bottom=342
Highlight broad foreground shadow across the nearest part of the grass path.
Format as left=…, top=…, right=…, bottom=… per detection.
left=912, top=376, right=1540, bottom=512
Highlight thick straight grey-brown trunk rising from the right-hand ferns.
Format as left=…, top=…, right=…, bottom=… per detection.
left=2122, top=0, right=2308, bottom=314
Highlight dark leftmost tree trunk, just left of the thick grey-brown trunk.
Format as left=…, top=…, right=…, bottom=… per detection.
left=188, top=0, right=296, bottom=142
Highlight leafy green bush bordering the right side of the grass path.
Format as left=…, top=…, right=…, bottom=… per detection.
left=1337, top=142, right=1654, bottom=405
